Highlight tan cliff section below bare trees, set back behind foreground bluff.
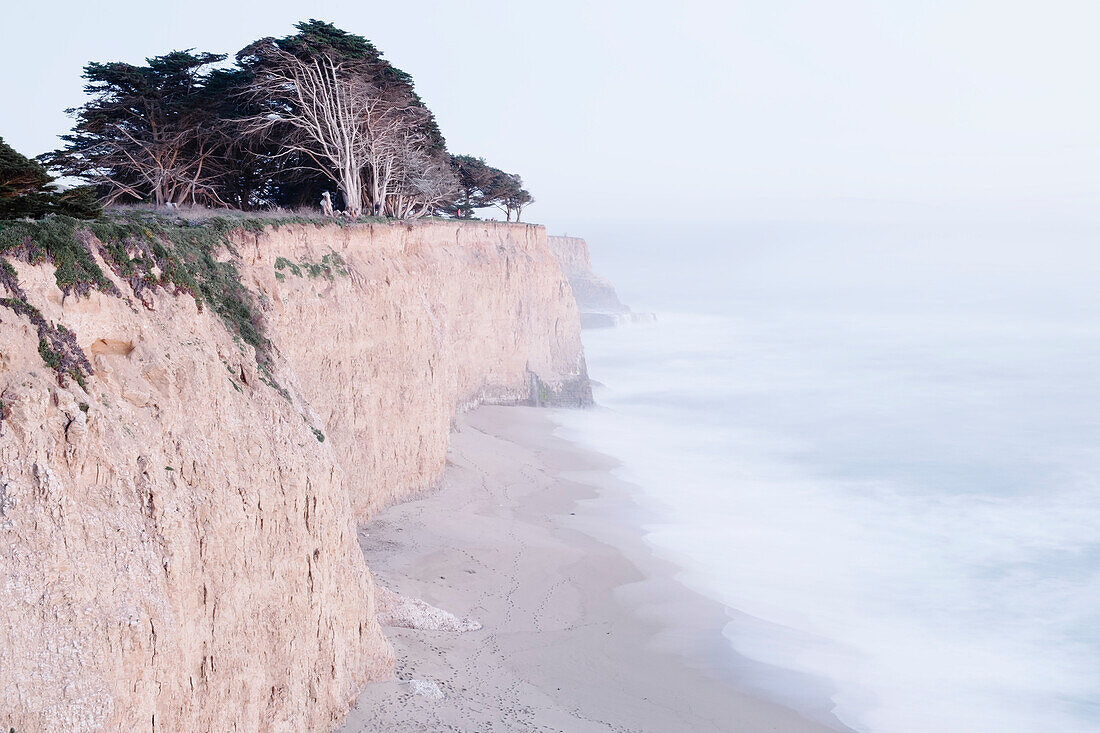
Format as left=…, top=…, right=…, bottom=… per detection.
left=240, top=222, right=592, bottom=512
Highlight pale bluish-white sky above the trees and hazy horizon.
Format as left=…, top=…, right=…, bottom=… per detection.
left=0, top=0, right=1100, bottom=230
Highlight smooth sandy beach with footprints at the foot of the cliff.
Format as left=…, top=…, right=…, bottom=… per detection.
left=341, top=407, right=845, bottom=733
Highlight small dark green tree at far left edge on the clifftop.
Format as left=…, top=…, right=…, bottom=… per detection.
left=0, top=138, right=100, bottom=219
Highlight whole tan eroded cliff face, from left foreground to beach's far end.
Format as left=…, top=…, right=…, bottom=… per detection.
left=0, top=217, right=590, bottom=731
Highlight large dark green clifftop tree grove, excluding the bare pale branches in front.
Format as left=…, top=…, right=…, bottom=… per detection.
left=38, top=20, right=534, bottom=215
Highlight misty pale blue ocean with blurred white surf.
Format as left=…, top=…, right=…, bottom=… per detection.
left=557, top=221, right=1100, bottom=733
